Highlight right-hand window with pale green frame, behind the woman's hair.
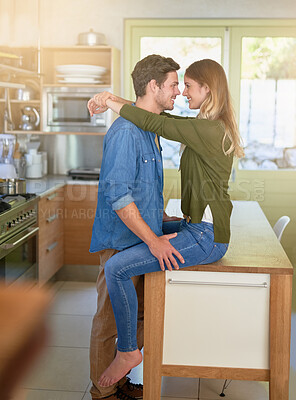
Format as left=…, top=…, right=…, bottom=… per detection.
left=232, top=21, right=296, bottom=170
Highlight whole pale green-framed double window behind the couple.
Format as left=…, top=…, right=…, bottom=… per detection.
left=125, top=20, right=296, bottom=169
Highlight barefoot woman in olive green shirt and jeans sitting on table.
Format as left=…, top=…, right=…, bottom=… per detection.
left=89, top=60, right=243, bottom=386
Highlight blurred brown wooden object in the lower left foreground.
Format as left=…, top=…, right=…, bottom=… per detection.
left=0, top=283, right=52, bottom=400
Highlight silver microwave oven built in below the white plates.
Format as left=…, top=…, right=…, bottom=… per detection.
left=42, top=86, right=112, bottom=132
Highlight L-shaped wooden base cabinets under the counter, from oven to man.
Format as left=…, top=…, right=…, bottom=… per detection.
left=38, top=183, right=99, bottom=285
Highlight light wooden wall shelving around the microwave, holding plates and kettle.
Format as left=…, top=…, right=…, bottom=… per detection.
left=0, top=45, right=120, bottom=135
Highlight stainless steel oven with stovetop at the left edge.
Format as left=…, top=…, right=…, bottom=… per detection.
left=0, top=194, right=39, bottom=284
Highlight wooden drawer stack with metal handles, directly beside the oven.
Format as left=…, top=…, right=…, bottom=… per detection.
left=38, top=188, right=64, bottom=285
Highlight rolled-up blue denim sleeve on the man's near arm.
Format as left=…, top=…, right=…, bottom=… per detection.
left=101, top=126, right=137, bottom=211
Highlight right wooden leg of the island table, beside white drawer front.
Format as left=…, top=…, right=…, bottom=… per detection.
left=269, top=274, right=292, bottom=400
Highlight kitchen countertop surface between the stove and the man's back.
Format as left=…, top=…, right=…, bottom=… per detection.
left=26, top=175, right=99, bottom=197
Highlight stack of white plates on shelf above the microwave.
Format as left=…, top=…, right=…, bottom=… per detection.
left=56, top=64, right=108, bottom=85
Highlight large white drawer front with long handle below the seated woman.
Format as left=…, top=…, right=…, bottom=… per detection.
left=163, top=270, right=270, bottom=369
